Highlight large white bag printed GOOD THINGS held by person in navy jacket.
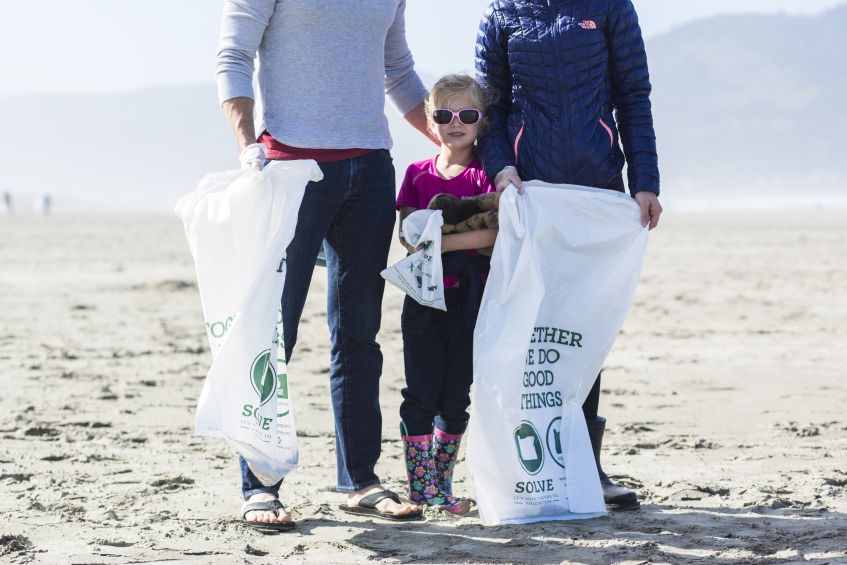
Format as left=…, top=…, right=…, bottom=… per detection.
left=468, top=182, right=647, bottom=525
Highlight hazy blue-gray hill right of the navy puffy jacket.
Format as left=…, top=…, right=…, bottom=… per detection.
left=647, top=6, right=847, bottom=204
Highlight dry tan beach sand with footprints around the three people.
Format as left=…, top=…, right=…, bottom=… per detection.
left=0, top=211, right=847, bottom=564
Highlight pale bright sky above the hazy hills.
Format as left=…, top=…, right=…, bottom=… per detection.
left=0, top=0, right=845, bottom=96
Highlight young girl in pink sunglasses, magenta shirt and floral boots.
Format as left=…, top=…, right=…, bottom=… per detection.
left=397, top=75, right=497, bottom=514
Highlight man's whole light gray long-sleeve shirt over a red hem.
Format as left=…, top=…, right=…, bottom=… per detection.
left=215, top=0, right=427, bottom=149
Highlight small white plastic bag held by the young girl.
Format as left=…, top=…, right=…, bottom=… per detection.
left=380, top=210, right=447, bottom=310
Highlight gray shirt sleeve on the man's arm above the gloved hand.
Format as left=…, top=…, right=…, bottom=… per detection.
left=215, top=0, right=276, bottom=104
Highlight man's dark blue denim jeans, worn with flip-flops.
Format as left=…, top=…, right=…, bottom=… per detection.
left=239, top=150, right=395, bottom=499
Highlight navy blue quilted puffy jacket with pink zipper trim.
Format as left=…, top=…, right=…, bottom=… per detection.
left=476, top=0, right=659, bottom=194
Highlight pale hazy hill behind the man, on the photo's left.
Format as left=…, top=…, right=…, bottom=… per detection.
left=0, top=83, right=430, bottom=212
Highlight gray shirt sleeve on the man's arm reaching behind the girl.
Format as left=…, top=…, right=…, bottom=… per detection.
left=385, top=0, right=428, bottom=115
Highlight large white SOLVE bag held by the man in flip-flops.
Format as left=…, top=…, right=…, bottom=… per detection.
left=175, top=161, right=323, bottom=485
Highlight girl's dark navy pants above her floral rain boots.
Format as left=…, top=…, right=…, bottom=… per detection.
left=400, top=288, right=473, bottom=436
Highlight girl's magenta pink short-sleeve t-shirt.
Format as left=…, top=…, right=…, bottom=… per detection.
left=397, top=155, right=496, bottom=289
